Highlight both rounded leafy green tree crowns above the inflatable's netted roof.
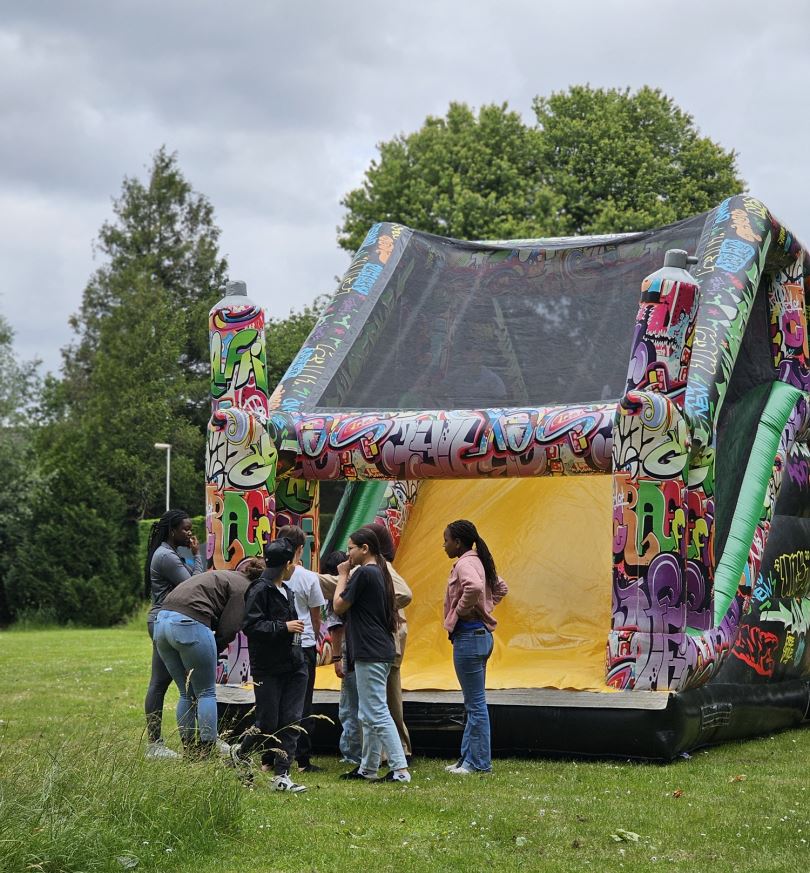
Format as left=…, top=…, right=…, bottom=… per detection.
left=338, top=86, right=744, bottom=251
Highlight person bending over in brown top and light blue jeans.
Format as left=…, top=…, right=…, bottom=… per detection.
left=155, top=559, right=264, bottom=754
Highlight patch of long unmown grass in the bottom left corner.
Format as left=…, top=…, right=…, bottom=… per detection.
left=0, top=730, right=244, bottom=873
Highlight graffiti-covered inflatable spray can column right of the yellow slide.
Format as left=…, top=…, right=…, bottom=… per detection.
left=606, top=249, right=706, bottom=691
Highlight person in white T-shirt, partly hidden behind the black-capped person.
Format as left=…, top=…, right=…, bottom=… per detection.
left=276, top=524, right=326, bottom=773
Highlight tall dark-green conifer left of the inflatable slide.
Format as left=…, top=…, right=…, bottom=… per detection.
left=7, top=149, right=226, bottom=624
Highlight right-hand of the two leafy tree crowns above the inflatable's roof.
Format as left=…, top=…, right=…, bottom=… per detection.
left=534, top=85, right=745, bottom=234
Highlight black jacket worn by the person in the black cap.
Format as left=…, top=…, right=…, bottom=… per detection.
left=242, top=572, right=304, bottom=675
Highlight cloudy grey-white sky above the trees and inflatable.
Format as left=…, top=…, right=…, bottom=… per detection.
left=0, top=0, right=810, bottom=369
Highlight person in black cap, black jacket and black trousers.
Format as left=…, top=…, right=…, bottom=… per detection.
left=231, top=537, right=308, bottom=793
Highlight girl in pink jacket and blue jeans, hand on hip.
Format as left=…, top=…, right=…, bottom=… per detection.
left=444, top=520, right=509, bottom=776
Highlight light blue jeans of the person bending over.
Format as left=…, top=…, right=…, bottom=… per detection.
left=155, top=609, right=217, bottom=745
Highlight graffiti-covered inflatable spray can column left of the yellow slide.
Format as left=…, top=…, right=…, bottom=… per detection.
left=205, top=282, right=277, bottom=568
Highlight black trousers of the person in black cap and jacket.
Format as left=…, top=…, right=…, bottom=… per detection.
left=239, top=661, right=308, bottom=775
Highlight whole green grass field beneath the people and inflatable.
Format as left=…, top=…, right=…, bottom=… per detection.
left=0, top=620, right=810, bottom=873
